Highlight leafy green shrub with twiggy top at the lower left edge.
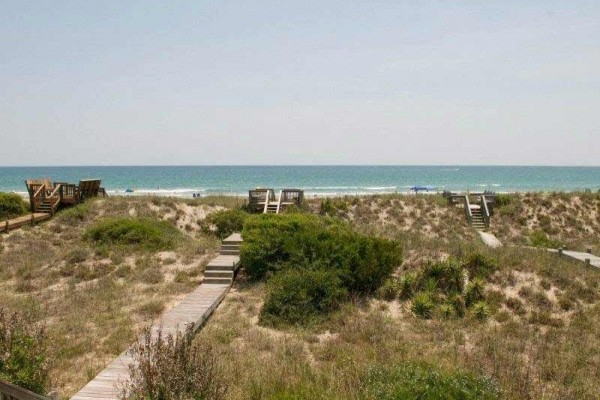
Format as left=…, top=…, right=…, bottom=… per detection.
left=0, top=308, right=50, bottom=394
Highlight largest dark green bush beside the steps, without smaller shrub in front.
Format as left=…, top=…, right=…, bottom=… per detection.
left=241, top=214, right=402, bottom=293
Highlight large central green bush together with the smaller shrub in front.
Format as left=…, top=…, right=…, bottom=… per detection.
left=241, top=213, right=402, bottom=325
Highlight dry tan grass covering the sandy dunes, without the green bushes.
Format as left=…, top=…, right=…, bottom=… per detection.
left=0, top=193, right=600, bottom=399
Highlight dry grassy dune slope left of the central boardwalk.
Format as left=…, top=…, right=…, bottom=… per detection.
left=0, top=197, right=224, bottom=397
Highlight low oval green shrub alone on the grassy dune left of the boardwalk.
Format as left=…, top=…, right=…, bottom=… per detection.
left=85, top=218, right=182, bottom=251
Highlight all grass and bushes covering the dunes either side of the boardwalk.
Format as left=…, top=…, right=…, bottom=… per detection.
left=0, top=193, right=600, bottom=400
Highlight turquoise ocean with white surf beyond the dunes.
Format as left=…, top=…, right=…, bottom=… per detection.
left=0, top=166, right=600, bottom=197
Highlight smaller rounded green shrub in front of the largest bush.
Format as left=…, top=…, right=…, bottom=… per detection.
left=260, top=268, right=347, bottom=325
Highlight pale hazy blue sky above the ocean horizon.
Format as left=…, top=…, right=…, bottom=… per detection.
left=0, top=0, right=600, bottom=166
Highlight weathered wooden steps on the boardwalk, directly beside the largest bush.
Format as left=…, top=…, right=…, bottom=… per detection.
left=202, top=233, right=242, bottom=285
